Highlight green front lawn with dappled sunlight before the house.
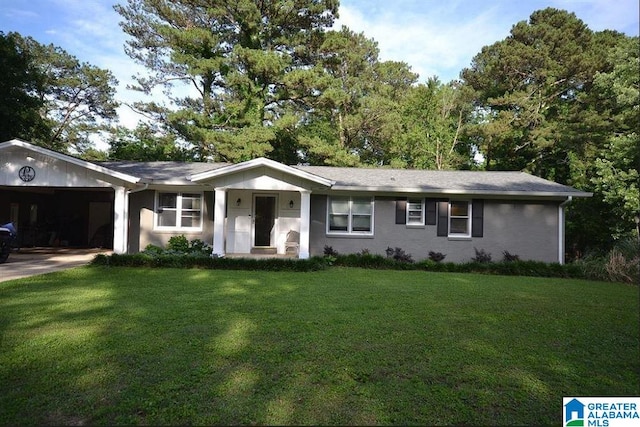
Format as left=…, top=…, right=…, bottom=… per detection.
left=0, top=267, right=640, bottom=425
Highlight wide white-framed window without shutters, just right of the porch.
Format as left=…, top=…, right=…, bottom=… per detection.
left=327, top=197, right=373, bottom=235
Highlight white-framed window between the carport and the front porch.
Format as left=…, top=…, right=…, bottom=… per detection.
left=155, top=191, right=203, bottom=230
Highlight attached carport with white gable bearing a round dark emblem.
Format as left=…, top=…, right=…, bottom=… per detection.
left=0, top=139, right=139, bottom=253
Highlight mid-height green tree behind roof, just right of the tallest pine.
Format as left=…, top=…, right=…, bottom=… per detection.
left=300, top=27, right=417, bottom=166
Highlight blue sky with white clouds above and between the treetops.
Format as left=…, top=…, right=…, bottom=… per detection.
left=0, top=0, right=640, bottom=130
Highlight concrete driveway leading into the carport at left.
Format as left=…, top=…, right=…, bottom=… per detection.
left=0, top=248, right=111, bottom=282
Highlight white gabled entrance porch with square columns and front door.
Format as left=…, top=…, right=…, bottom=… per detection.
left=189, top=158, right=333, bottom=258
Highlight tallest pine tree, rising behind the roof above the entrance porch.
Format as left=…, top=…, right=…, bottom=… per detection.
left=115, top=0, right=338, bottom=161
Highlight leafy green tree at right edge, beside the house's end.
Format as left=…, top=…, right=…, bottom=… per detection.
left=569, top=37, right=640, bottom=248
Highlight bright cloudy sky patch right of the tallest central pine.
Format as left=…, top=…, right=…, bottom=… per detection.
left=334, top=0, right=638, bottom=82
